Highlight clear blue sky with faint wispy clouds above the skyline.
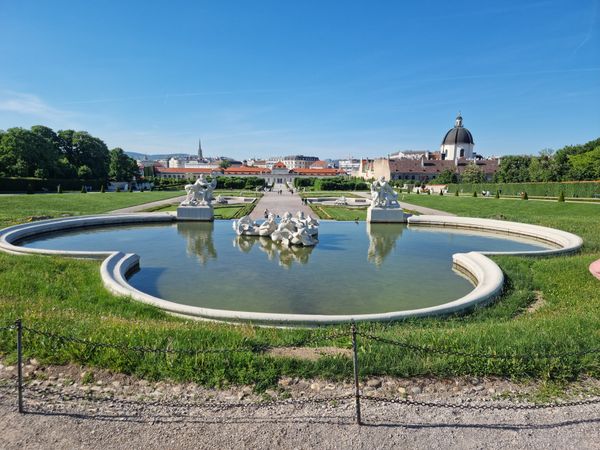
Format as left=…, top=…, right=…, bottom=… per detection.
left=0, top=0, right=600, bottom=158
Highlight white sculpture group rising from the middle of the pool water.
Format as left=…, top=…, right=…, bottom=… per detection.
left=233, top=211, right=319, bottom=247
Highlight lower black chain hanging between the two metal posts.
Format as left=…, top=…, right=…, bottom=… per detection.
left=29, top=387, right=354, bottom=409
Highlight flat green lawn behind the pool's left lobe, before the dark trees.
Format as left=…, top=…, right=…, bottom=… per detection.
left=0, top=191, right=181, bottom=227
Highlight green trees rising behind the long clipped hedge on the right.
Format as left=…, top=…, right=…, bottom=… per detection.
left=431, top=138, right=600, bottom=184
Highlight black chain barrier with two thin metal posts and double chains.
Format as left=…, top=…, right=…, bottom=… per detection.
left=0, top=320, right=600, bottom=425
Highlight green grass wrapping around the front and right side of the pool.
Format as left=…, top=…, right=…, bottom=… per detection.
left=0, top=194, right=600, bottom=390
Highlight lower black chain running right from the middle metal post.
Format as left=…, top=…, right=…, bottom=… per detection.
left=360, top=395, right=600, bottom=411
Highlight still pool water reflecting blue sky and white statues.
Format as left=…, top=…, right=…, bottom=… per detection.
left=19, top=221, right=552, bottom=314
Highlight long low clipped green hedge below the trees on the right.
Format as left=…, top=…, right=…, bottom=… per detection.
left=448, top=181, right=600, bottom=197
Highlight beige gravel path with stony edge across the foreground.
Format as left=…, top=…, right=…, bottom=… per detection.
left=0, top=360, right=600, bottom=449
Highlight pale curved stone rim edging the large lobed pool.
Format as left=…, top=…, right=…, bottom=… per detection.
left=0, top=213, right=583, bottom=326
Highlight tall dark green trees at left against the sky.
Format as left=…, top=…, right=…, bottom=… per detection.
left=0, top=125, right=139, bottom=181
